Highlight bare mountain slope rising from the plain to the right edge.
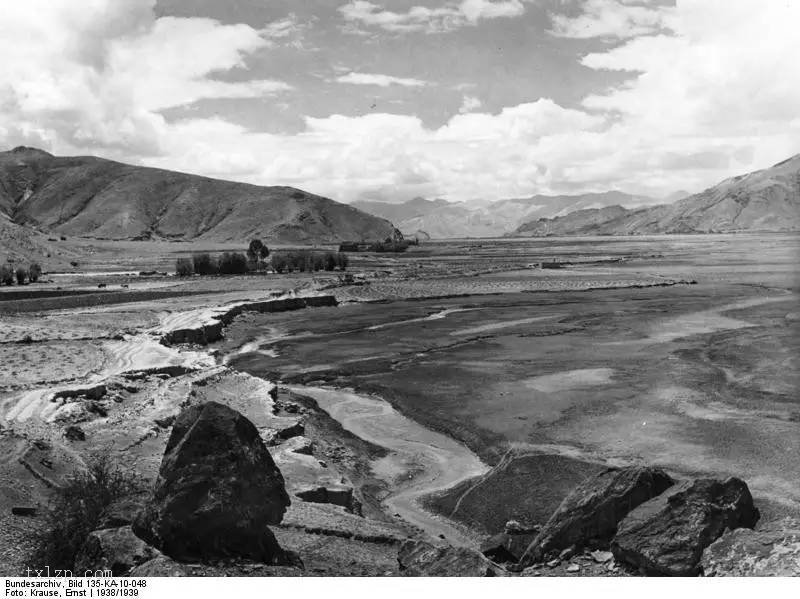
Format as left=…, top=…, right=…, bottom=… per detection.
left=514, top=154, right=800, bottom=236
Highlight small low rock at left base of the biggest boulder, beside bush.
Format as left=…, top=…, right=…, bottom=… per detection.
left=75, top=526, right=160, bottom=576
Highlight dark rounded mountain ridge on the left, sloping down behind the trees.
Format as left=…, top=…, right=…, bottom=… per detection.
left=0, top=147, right=398, bottom=243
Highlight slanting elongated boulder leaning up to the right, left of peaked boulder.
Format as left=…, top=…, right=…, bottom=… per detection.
left=519, top=466, right=674, bottom=568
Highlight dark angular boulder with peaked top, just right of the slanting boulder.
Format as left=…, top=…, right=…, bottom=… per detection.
left=611, top=478, right=759, bottom=576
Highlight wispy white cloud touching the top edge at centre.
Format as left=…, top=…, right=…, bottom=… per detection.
left=339, top=0, right=525, bottom=33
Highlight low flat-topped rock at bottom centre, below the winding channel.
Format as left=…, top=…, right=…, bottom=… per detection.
left=397, top=540, right=502, bottom=576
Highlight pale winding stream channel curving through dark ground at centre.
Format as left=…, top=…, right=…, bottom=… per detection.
left=290, top=386, right=489, bottom=546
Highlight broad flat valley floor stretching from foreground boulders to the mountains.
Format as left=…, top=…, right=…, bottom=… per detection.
left=0, top=235, right=800, bottom=574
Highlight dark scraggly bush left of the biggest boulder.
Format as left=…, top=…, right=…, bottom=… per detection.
left=31, top=455, right=143, bottom=570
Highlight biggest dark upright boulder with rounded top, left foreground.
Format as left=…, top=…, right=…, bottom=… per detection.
left=134, top=402, right=290, bottom=564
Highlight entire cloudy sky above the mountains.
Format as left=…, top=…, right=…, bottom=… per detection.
left=0, top=0, right=800, bottom=202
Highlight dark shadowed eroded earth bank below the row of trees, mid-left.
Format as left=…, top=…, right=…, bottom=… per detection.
left=161, top=295, right=339, bottom=345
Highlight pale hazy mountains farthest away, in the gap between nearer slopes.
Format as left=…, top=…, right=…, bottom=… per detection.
left=353, top=191, right=656, bottom=239
